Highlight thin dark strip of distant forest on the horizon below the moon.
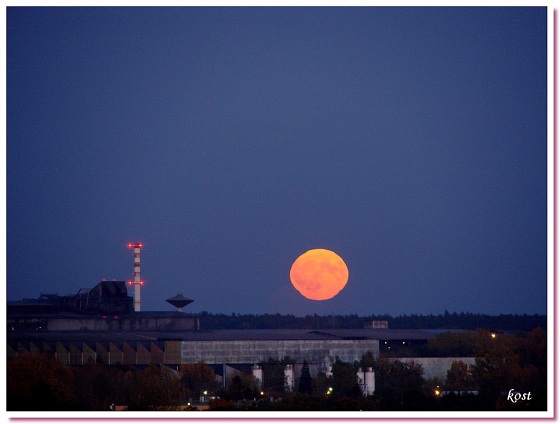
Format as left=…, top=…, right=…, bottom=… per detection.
left=194, top=310, right=546, bottom=331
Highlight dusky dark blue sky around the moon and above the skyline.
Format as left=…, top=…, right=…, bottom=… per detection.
left=7, top=7, right=547, bottom=315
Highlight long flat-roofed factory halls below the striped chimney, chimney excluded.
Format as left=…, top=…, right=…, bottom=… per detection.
left=7, top=304, right=446, bottom=378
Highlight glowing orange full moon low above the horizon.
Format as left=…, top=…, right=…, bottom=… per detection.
left=290, top=249, right=348, bottom=300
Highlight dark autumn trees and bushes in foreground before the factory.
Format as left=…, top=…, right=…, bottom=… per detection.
left=7, top=328, right=547, bottom=414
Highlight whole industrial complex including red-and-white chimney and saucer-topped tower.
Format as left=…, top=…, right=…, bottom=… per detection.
left=7, top=243, right=456, bottom=390
